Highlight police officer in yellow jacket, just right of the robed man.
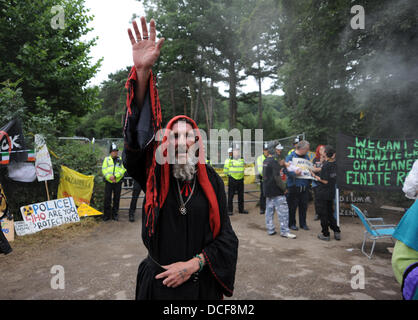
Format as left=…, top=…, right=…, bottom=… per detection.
left=224, top=147, right=248, bottom=215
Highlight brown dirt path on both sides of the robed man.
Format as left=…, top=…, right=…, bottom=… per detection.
left=0, top=188, right=401, bottom=300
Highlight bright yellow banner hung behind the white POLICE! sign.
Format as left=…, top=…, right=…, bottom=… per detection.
left=58, top=166, right=94, bottom=206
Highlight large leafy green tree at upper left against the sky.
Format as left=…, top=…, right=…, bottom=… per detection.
left=0, top=0, right=100, bottom=134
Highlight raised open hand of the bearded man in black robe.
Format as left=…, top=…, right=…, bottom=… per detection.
left=128, top=17, right=164, bottom=72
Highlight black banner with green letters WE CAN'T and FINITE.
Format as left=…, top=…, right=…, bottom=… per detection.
left=337, top=134, right=418, bottom=190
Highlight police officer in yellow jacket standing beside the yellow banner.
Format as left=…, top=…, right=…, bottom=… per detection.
left=102, top=143, right=126, bottom=221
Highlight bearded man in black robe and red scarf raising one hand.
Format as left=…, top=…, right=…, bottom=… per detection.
left=123, top=17, right=238, bottom=300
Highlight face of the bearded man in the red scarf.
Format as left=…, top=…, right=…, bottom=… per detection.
left=170, top=120, right=197, bottom=164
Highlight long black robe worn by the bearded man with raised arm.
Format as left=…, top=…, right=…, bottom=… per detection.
left=123, top=84, right=238, bottom=300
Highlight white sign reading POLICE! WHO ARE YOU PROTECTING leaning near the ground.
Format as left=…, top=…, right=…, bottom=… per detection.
left=15, top=197, right=80, bottom=236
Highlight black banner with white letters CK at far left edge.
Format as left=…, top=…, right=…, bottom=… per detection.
left=0, top=119, right=28, bottom=165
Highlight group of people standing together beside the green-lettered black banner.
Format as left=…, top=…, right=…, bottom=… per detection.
left=256, top=139, right=341, bottom=241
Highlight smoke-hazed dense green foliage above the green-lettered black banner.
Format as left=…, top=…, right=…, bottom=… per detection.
left=277, top=0, right=418, bottom=144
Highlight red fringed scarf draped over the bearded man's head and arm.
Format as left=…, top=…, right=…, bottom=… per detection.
left=126, top=67, right=220, bottom=238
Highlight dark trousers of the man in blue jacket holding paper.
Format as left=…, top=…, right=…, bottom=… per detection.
left=287, top=187, right=309, bottom=228
